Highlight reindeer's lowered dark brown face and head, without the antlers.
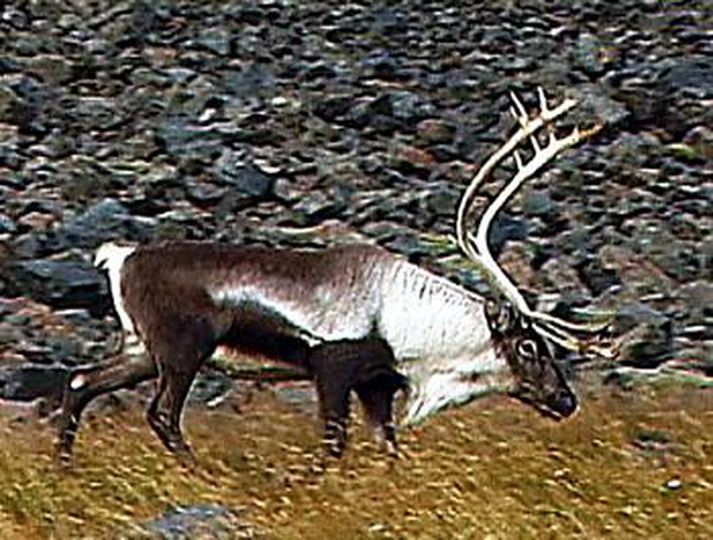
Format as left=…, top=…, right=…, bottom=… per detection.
left=485, top=301, right=578, bottom=420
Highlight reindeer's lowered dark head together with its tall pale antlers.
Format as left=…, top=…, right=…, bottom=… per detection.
left=456, top=88, right=615, bottom=418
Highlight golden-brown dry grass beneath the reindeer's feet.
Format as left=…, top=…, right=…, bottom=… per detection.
left=0, top=382, right=713, bottom=540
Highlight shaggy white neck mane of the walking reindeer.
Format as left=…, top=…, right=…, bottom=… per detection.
left=378, top=262, right=512, bottom=424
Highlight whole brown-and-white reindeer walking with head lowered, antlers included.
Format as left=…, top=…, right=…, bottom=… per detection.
left=57, top=89, right=613, bottom=457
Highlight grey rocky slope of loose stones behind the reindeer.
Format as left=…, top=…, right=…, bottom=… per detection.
left=0, top=0, right=713, bottom=399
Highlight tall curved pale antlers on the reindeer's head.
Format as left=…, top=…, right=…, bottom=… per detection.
left=456, top=88, right=614, bottom=357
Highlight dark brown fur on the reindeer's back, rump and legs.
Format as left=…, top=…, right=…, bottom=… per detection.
left=58, top=242, right=405, bottom=456
